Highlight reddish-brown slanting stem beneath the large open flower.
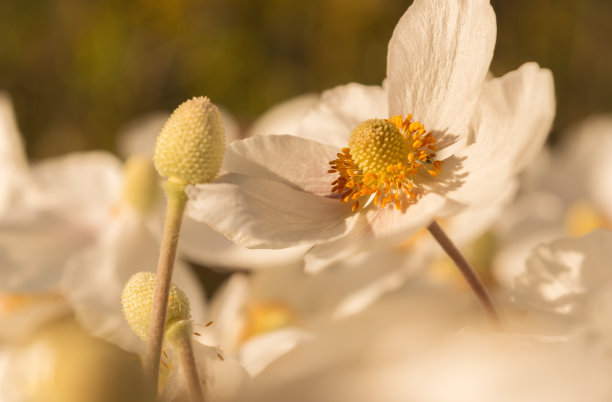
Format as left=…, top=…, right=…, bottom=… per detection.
left=427, top=220, right=503, bottom=331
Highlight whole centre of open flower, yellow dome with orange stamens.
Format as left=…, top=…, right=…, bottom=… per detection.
left=329, top=114, right=442, bottom=211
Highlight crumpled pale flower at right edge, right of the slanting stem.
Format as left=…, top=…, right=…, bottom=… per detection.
left=513, top=230, right=612, bottom=350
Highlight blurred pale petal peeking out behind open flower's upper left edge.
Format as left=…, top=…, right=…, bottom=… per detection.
left=245, top=94, right=319, bottom=137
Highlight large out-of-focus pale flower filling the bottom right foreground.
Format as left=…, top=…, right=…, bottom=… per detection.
left=240, top=283, right=612, bottom=402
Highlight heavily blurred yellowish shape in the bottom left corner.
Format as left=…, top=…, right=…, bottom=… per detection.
left=0, top=318, right=146, bottom=402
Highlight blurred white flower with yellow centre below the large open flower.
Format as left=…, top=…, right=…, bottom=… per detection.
left=198, top=248, right=424, bottom=376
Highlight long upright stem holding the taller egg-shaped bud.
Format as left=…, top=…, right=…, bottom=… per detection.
left=145, top=177, right=187, bottom=390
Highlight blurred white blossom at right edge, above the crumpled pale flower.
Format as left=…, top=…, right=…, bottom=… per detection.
left=493, top=115, right=612, bottom=286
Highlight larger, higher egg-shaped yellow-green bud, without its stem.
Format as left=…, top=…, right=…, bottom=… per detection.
left=153, top=96, right=225, bottom=185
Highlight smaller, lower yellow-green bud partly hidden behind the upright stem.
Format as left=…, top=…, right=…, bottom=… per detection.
left=121, top=272, right=191, bottom=341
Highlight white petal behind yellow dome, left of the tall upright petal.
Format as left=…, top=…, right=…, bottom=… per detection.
left=297, top=83, right=389, bottom=149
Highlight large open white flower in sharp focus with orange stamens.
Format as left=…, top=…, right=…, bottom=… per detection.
left=187, top=0, right=554, bottom=264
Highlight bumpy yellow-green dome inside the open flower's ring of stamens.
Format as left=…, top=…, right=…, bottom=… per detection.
left=349, top=119, right=407, bottom=173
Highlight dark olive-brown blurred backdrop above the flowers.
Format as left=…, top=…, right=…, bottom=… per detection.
left=0, top=0, right=612, bottom=159
